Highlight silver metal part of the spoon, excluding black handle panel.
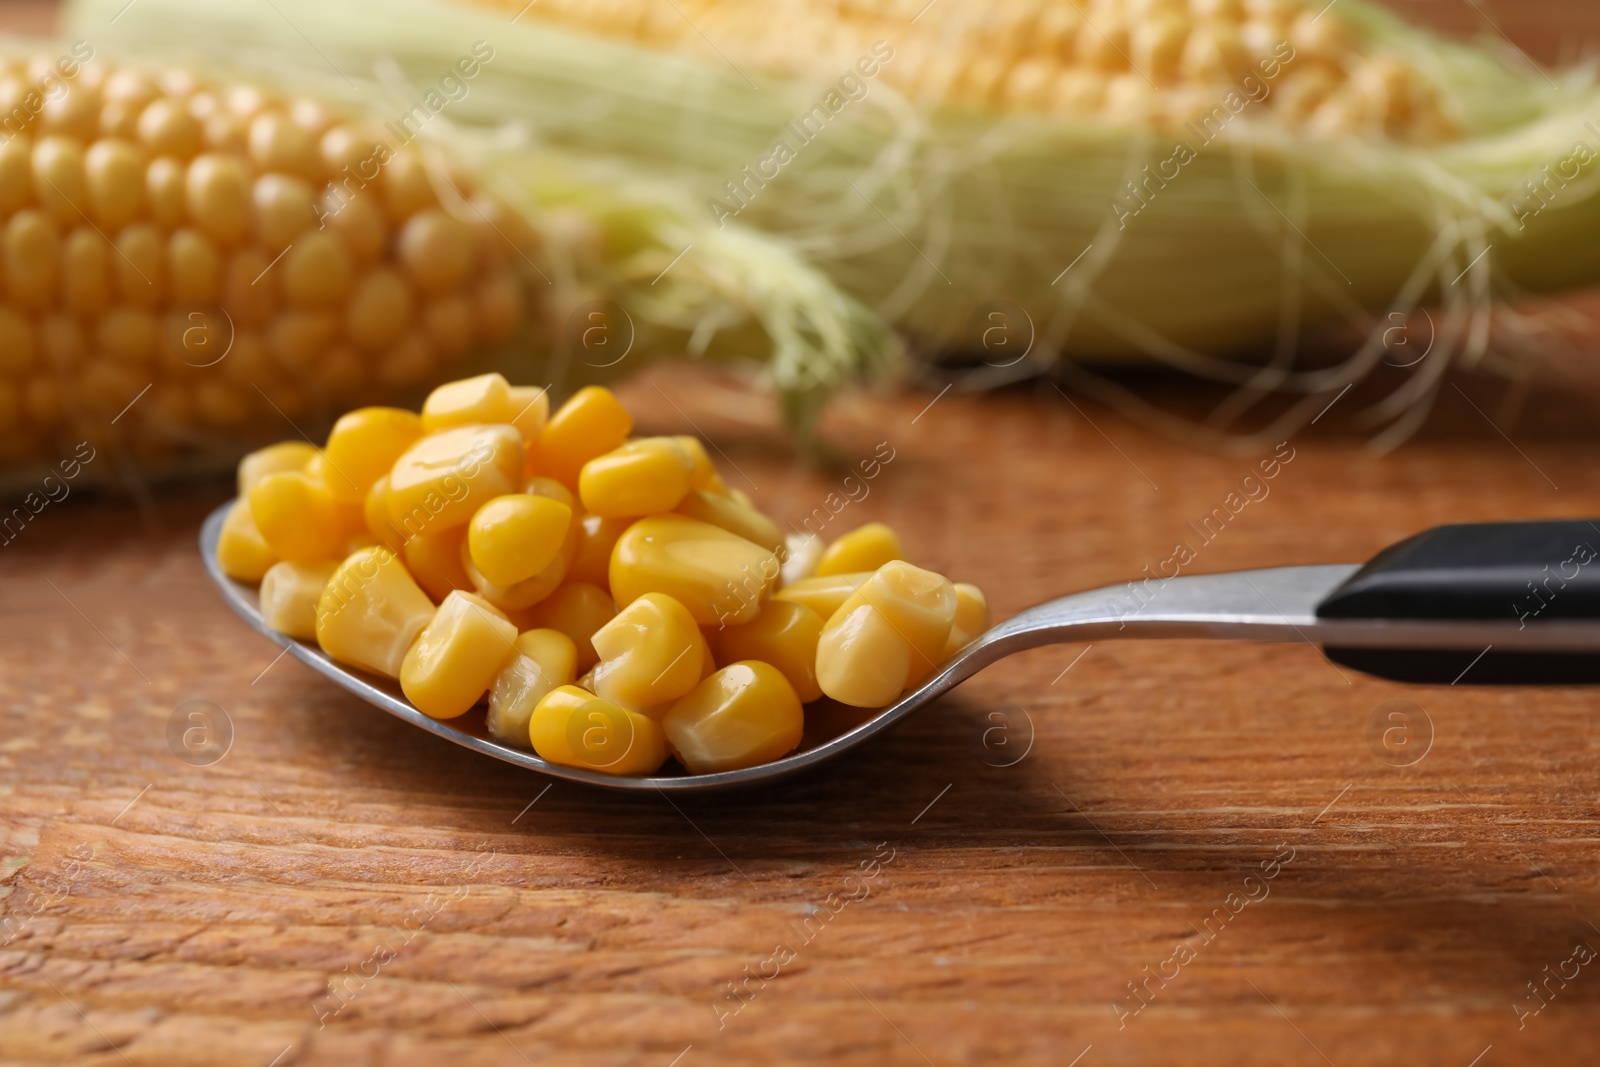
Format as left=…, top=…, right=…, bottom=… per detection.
left=200, top=504, right=1597, bottom=793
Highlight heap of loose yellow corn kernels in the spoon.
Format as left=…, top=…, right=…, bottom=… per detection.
left=218, top=374, right=989, bottom=774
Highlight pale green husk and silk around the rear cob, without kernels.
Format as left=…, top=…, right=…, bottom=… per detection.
left=72, top=0, right=1600, bottom=432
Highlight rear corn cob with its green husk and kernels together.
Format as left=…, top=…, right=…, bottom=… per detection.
left=74, top=0, right=1600, bottom=441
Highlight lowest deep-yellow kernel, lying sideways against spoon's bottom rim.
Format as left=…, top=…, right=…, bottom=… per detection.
left=528, top=685, right=667, bottom=774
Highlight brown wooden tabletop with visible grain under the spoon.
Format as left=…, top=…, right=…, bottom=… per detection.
left=9, top=3, right=1600, bottom=1067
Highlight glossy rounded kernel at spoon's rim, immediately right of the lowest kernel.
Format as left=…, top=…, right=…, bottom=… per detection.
left=661, top=659, right=805, bottom=774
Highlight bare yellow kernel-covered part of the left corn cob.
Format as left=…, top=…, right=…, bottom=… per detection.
left=0, top=45, right=538, bottom=461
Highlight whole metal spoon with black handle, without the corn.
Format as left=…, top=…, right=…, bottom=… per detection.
left=200, top=504, right=1600, bottom=793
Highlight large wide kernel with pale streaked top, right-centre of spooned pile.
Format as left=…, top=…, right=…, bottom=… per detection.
left=608, top=515, right=779, bottom=625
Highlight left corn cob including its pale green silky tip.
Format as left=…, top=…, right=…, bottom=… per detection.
left=0, top=42, right=883, bottom=479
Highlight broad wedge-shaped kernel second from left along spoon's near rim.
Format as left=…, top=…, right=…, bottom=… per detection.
left=317, top=545, right=434, bottom=678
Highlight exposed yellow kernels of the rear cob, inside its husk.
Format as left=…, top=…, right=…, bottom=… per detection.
left=518, top=0, right=1454, bottom=141
